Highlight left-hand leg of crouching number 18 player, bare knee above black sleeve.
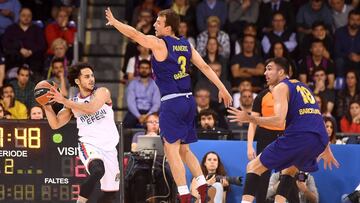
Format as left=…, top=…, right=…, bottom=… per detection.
left=241, top=155, right=268, bottom=203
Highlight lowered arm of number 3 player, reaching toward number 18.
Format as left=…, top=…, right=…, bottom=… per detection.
left=191, top=46, right=232, bottom=107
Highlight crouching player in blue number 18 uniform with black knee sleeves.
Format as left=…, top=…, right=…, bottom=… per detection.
left=228, top=58, right=339, bottom=203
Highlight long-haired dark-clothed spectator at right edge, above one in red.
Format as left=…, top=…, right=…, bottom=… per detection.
left=336, top=70, right=360, bottom=118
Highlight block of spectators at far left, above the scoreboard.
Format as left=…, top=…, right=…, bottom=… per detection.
left=0, top=0, right=80, bottom=119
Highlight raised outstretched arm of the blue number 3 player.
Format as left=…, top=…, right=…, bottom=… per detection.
left=105, top=8, right=164, bottom=50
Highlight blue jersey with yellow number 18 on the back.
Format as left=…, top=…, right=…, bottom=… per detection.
left=282, top=79, right=328, bottom=143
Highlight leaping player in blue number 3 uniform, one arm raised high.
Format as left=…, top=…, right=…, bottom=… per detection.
left=105, top=8, right=232, bottom=203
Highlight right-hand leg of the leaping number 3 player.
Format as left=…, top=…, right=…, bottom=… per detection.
left=180, top=144, right=208, bottom=202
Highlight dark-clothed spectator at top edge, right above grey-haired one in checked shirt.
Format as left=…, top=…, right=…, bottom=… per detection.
left=196, top=0, right=228, bottom=32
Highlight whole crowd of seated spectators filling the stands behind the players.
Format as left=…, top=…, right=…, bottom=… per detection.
left=0, top=0, right=360, bottom=144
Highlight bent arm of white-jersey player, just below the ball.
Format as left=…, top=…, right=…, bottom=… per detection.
left=43, top=105, right=72, bottom=129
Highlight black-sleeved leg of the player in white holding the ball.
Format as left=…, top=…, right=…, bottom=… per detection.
left=77, top=159, right=105, bottom=203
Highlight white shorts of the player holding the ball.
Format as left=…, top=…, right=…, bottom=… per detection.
left=78, top=142, right=120, bottom=192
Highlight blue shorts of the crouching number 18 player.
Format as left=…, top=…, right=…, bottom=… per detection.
left=260, top=132, right=327, bottom=172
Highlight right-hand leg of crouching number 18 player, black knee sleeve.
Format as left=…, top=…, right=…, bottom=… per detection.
left=275, top=166, right=299, bottom=203
